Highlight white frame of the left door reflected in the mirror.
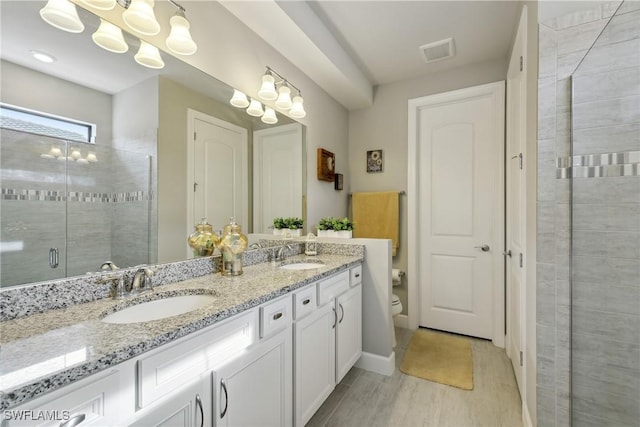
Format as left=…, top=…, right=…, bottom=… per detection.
left=185, top=108, right=249, bottom=259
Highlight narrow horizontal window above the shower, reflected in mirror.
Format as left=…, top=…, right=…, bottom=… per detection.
left=0, top=103, right=96, bottom=144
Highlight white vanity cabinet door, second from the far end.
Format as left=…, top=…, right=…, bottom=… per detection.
left=294, top=303, right=337, bottom=426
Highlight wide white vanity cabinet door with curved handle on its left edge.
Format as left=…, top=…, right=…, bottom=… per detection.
left=214, top=327, right=293, bottom=427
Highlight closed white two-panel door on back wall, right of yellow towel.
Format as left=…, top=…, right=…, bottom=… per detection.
left=410, top=82, right=504, bottom=342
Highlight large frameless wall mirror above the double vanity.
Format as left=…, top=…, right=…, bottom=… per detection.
left=0, top=1, right=306, bottom=287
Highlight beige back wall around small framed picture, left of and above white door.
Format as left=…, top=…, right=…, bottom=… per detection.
left=345, top=60, right=507, bottom=314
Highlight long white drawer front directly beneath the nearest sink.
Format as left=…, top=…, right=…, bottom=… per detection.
left=137, top=309, right=258, bottom=408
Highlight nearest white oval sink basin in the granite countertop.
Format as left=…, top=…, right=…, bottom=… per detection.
left=102, top=295, right=216, bottom=323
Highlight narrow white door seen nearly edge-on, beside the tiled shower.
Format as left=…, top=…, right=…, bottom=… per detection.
left=505, top=6, right=527, bottom=396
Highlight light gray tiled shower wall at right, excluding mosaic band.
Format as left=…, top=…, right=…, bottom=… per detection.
left=537, top=2, right=640, bottom=426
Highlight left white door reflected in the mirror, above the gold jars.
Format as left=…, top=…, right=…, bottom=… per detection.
left=187, top=110, right=249, bottom=251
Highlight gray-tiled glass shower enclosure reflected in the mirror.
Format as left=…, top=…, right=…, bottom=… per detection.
left=0, top=128, right=153, bottom=287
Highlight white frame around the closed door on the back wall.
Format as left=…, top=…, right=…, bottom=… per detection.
left=407, top=81, right=505, bottom=347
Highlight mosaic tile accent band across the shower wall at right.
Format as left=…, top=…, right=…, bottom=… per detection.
left=556, top=151, right=640, bottom=179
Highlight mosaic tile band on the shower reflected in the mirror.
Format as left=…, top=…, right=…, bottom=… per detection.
left=0, top=188, right=153, bottom=203
